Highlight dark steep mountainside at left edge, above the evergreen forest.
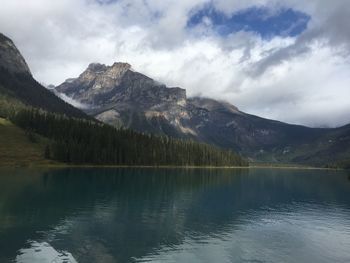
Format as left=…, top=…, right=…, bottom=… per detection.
left=0, top=33, right=90, bottom=119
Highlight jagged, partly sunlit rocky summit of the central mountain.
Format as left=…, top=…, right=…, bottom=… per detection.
left=56, top=62, right=186, bottom=109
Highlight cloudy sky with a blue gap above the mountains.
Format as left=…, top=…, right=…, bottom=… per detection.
left=0, top=0, right=350, bottom=127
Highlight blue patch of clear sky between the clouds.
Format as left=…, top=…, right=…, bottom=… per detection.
left=187, top=5, right=311, bottom=38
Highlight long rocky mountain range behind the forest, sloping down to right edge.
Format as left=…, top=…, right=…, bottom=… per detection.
left=56, top=63, right=350, bottom=165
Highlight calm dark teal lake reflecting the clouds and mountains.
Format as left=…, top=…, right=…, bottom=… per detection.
left=0, top=168, right=350, bottom=263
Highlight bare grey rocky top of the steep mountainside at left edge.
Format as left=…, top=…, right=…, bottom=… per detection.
left=0, top=33, right=31, bottom=75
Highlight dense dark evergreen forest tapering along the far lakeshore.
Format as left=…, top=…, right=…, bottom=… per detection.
left=11, top=109, right=248, bottom=166
